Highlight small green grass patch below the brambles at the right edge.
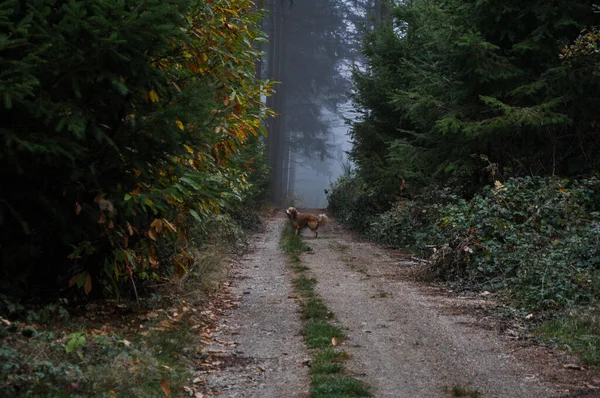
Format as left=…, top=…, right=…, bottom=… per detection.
left=534, top=312, right=600, bottom=369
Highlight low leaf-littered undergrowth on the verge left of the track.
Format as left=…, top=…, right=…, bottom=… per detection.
left=0, top=213, right=255, bottom=397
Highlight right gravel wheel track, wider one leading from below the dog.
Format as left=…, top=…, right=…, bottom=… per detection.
left=303, top=219, right=561, bottom=398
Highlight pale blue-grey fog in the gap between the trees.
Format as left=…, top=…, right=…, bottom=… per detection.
left=259, top=0, right=376, bottom=208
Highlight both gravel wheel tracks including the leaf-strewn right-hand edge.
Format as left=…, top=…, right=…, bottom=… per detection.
left=194, top=211, right=600, bottom=398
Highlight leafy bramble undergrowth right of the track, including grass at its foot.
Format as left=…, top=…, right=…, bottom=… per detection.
left=328, top=176, right=600, bottom=363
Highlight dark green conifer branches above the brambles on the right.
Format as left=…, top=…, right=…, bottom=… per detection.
left=351, top=0, right=600, bottom=202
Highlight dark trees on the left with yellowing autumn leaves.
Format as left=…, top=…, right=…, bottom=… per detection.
left=0, top=0, right=270, bottom=294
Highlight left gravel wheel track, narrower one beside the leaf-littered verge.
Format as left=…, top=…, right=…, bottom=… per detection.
left=199, top=220, right=309, bottom=398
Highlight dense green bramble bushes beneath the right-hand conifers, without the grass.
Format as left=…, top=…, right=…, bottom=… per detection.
left=330, top=177, right=600, bottom=310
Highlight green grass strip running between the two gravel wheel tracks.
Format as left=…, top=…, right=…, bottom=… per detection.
left=280, top=223, right=370, bottom=398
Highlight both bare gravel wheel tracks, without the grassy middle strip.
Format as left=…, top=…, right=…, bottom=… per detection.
left=199, top=214, right=592, bottom=398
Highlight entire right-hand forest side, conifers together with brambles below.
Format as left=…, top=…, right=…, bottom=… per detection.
left=328, top=0, right=600, bottom=363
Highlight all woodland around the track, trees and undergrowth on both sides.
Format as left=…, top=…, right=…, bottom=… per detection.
left=0, top=0, right=600, bottom=396
